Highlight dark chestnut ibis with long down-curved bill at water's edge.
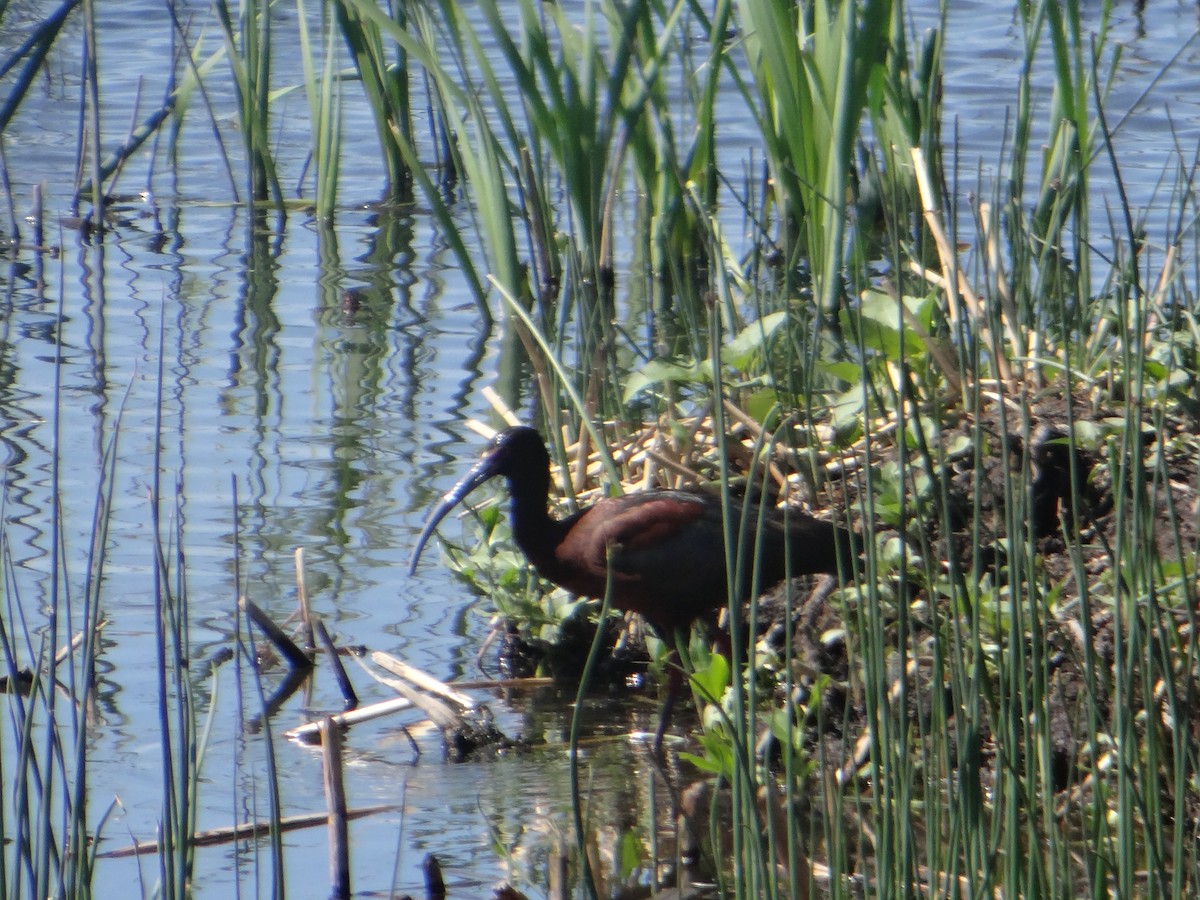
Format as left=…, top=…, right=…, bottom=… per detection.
left=409, top=427, right=858, bottom=736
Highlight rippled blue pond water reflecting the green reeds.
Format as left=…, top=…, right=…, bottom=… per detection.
left=0, top=2, right=1200, bottom=896
